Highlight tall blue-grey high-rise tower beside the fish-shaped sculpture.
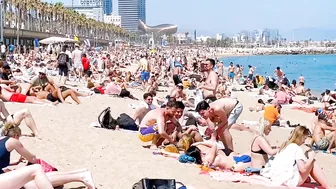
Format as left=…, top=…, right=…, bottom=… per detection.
left=118, top=0, right=146, bottom=31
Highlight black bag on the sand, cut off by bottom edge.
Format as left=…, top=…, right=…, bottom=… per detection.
left=132, top=178, right=176, bottom=189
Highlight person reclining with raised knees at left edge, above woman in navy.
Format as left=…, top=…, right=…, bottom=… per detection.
left=0, top=100, right=41, bottom=139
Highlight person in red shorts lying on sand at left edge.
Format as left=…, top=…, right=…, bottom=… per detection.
left=0, top=85, right=52, bottom=104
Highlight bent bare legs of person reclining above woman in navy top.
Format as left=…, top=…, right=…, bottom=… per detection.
left=7, top=109, right=41, bottom=138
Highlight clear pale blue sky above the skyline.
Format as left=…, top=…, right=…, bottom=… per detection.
left=53, top=0, right=336, bottom=37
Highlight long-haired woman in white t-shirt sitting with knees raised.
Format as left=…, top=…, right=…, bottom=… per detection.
left=267, top=126, right=332, bottom=189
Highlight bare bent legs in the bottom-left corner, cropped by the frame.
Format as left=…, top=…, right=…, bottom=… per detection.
left=0, top=164, right=53, bottom=189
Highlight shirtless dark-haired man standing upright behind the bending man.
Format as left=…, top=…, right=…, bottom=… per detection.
left=198, top=59, right=219, bottom=101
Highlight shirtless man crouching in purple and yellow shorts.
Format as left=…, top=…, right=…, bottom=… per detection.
left=139, top=101, right=182, bottom=148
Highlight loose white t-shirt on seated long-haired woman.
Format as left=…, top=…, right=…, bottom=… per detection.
left=270, top=143, right=306, bottom=187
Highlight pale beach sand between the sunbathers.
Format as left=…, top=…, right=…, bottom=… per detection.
left=6, top=90, right=336, bottom=189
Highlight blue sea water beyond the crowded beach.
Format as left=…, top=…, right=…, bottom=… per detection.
left=221, top=55, right=336, bottom=92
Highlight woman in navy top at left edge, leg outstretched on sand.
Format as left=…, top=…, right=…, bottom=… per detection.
left=0, top=124, right=95, bottom=189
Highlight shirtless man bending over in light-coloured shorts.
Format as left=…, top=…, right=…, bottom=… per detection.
left=195, top=98, right=243, bottom=150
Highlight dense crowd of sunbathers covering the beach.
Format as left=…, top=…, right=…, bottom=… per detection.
left=0, top=45, right=336, bottom=189
